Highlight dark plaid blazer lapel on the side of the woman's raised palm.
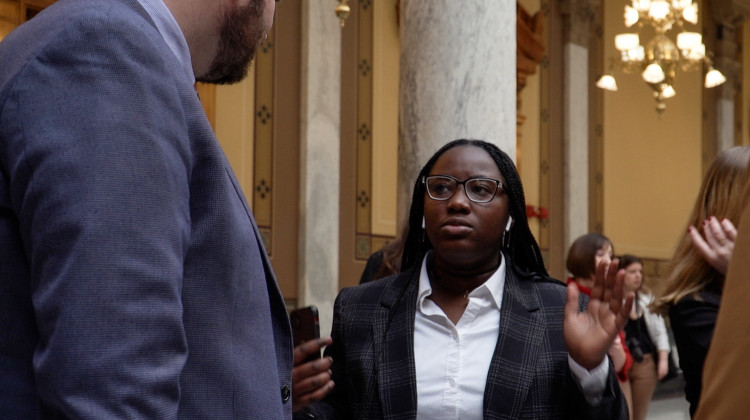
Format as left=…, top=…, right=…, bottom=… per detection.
left=484, top=267, right=545, bottom=418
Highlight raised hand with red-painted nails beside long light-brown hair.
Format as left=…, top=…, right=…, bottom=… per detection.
left=688, top=216, right=737, bottom=274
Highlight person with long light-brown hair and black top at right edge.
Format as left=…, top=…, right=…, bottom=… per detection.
left=652, top=146, right=750, bottom=416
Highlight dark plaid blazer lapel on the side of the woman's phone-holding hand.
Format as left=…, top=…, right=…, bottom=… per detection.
left=372, top=266, right=419, bottom=419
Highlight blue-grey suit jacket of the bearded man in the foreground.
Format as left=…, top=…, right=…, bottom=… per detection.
left=0, top=0, right=292, bottom=419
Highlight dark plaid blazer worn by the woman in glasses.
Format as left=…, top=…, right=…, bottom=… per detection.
left=296, top=256, right=628, bottom=420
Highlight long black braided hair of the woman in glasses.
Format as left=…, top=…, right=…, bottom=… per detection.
left=401, top=139, right=549, bottom=277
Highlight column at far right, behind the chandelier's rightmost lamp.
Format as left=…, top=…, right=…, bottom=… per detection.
left=712, top=0, right=750, bottom=153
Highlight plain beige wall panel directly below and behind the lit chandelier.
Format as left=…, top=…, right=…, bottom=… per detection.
left=603, top=0, right=703, bottom=259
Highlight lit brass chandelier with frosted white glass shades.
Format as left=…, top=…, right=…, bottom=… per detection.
left=596, top=0, right=726, bottom=115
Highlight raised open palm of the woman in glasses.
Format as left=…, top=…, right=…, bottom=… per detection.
left=563, top=259, right=635, bottom=370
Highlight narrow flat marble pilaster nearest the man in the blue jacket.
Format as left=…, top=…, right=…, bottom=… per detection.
left=297, top=1, right=341, bottom=335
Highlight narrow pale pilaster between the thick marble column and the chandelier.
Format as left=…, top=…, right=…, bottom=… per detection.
left=560, top=0, right=599, bottom=249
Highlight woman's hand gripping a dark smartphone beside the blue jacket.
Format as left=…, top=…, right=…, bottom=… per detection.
left=292, top=337, right=334, bottom=411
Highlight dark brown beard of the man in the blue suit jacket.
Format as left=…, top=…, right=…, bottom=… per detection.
left=197, top=0, right=265, bottom=85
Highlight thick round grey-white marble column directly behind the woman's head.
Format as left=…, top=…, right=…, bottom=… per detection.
left=397, top=0, right=516, bottom=221
